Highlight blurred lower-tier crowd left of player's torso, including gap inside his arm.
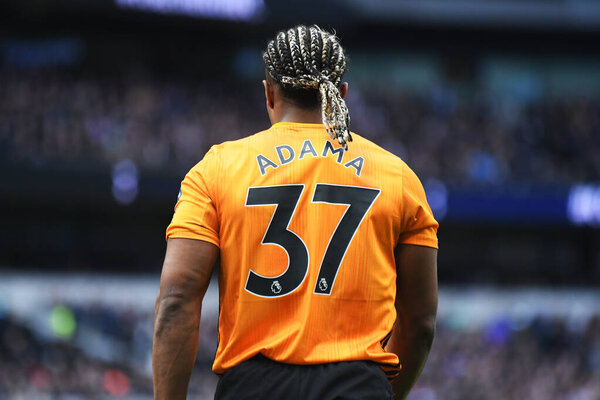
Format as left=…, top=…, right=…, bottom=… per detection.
left=0, top=304, right=217, bottom=400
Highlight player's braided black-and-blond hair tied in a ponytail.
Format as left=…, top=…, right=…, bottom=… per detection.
left=263, top=25, right=352, bottom=150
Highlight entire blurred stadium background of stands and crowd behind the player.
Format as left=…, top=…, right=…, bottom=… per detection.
left=0, top=0, right=600, bottom=400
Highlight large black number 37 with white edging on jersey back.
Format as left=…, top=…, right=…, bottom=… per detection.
left=246, top=183, right=381, bottom=297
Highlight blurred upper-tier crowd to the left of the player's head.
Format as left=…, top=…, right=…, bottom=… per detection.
left=0, top=71, right=268, bottom=170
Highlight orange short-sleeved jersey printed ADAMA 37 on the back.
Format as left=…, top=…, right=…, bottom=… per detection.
left=167, top=123, right=438, bottom=377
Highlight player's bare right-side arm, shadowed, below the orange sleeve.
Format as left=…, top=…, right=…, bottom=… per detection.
left=388, top=245, right=438, bottom=400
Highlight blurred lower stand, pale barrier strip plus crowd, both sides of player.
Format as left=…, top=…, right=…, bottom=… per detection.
left=0, top=273, right=600, bottom=400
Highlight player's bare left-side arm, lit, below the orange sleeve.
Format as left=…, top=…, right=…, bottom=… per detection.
left=152, top=239, right=219, bottom=400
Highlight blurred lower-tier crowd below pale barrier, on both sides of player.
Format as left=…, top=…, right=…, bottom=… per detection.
left=0, top=305, right=600, bottom=400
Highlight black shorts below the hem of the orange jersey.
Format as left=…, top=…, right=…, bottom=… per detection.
left=215, top=354, right=394, bottom=400
